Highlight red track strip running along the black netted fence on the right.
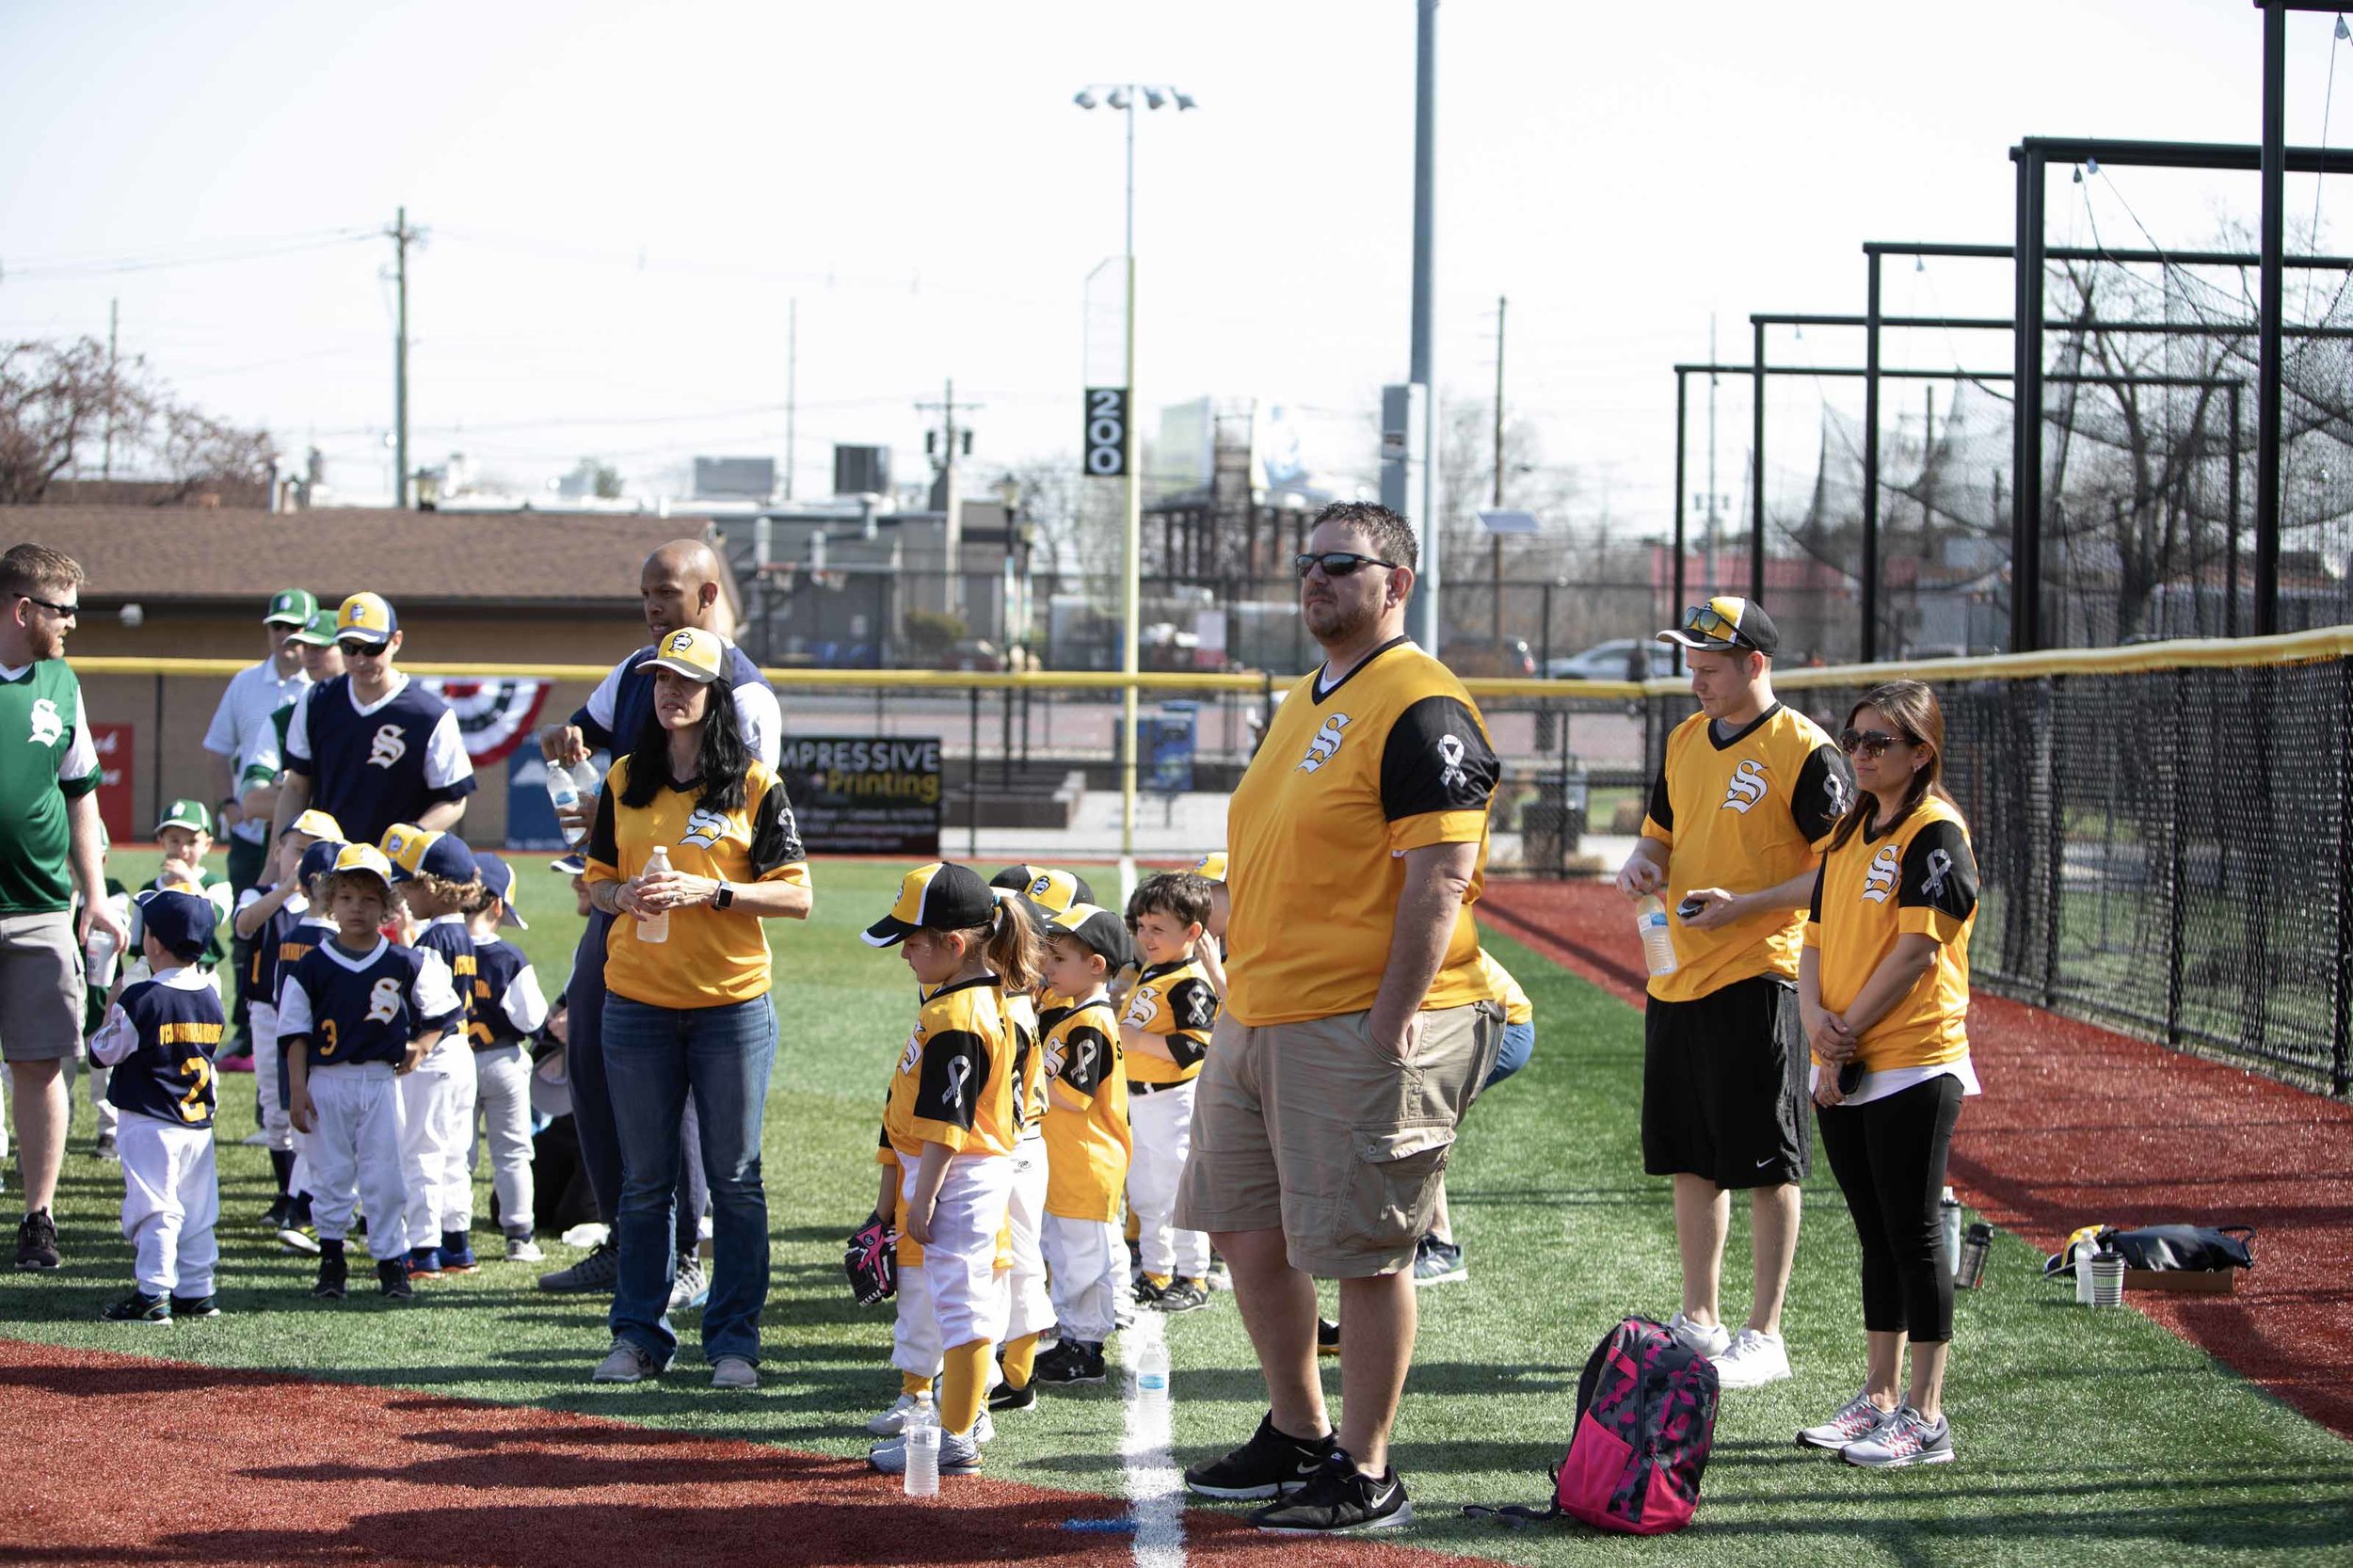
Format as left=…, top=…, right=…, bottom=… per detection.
left=1478, top=881, right=2353, bottom=1436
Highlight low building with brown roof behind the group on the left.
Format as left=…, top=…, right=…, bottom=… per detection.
left=0, top=506, right=739, bottom=845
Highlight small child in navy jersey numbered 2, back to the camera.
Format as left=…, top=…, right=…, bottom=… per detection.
left=89, top=890, right=226, bottom=1323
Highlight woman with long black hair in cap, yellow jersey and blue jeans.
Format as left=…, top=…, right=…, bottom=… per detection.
left=586, top=626, right=809, bottom=1389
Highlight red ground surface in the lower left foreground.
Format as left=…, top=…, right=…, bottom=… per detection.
left=0, top=1339, right=1495, bottom=1568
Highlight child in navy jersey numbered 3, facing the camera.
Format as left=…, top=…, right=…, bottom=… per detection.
left=278, top=843, right=464, bottom=1302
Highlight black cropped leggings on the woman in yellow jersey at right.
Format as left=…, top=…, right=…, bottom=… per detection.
left=1819, top=1074, right=1961, bottom=1344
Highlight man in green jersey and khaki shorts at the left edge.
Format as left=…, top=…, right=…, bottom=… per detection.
left=0, top=544, right=125, bottom=1269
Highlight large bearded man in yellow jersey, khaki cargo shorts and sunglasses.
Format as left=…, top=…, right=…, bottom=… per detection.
left=1176, top=502, right=1504, bottom=1532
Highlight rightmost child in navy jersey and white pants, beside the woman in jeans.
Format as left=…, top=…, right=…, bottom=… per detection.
left=466, top=853, right=549, bottom=1262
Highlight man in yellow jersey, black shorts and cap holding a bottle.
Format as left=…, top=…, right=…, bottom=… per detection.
left=1617, top=598, right=1854, bottom=1389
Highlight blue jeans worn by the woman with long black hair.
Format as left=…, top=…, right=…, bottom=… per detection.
left=605, top=991, right=776, bottom=1363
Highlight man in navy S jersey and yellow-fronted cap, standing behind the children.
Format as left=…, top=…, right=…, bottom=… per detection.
left=271, top=593, right=475, bottom=843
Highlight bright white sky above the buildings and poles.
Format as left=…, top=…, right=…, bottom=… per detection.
left=0, top=0, right=2353, bottom=532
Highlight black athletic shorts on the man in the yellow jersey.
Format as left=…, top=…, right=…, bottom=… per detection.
left=1642, top=975, right=1815, bottom=1187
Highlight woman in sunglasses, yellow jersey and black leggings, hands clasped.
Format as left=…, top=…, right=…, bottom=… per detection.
left=1798, top=680, right=1977, bottom=1466
